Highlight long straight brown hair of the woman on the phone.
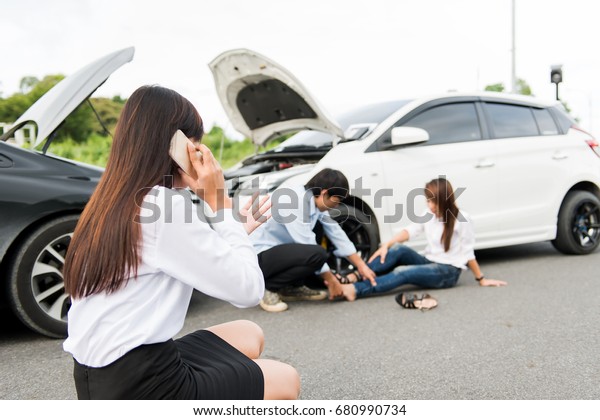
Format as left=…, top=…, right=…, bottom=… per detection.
left=64, top=86, right=203, bottom=298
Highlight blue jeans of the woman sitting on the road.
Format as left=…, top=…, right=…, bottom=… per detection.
left=354, top=245, right=461, bottom=297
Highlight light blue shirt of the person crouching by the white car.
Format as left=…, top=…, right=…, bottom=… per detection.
left=250, top=186, right=356, bottom=274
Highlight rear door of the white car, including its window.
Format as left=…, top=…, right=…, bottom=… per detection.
left=482, top=101, right=576, bottom=242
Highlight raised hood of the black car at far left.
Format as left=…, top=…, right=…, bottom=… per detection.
left=2, top=47, right=135, bottom=148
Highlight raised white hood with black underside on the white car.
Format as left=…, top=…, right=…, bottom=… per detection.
left=209, top=49, right=344, bottom=146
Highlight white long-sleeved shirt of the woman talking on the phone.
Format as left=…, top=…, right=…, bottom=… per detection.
left=63, top=187, right=264, bottom=367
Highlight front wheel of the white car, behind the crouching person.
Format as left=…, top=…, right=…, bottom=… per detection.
left=326, top=204, right=379, bottom=271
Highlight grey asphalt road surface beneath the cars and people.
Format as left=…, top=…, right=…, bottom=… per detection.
left=0, top=243, right=600, bottom=400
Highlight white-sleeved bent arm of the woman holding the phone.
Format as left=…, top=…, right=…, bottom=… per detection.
left=155, top=189, right=264, bottom=307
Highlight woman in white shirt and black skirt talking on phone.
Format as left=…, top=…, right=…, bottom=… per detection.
left=64, top=86, right=300, bottom=400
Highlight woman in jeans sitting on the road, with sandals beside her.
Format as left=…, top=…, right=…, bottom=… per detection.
left=342, top=178, right=507, bottom=309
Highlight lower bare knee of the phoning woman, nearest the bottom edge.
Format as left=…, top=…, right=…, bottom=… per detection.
left=255, top=359, right=300, bottom=400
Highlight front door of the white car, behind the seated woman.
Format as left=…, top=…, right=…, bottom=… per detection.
left=375, top=97, right=501, bottom=246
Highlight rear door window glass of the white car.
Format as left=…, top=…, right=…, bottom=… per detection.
left=486, top=103, right=539, bottom=138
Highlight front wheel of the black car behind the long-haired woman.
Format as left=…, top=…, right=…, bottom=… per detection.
left=7, top=215, right=79, bottom=338
